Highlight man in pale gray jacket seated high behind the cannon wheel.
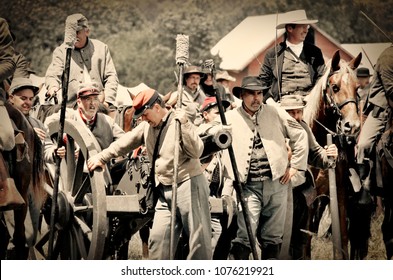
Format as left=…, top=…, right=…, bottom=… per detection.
left=45, top=14, right=119, bottom=117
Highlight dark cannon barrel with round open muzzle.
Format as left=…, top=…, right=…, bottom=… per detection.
left=200, top=130, right=232, bottom=160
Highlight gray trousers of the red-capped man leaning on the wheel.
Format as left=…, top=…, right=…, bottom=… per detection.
left=149, top=174, right=212, bottom=260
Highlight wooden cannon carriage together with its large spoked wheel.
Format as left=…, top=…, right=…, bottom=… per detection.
left=30, top=119, right=232, bottom=260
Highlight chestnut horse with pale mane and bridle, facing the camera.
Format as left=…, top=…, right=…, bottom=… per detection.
left=303, top=51, right=364, bottom=259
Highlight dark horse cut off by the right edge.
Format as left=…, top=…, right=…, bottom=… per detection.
left=376, top=111, right=393, bottom=260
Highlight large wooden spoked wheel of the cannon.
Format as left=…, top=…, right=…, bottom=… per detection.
left=34, top=119, right=110, bottom=259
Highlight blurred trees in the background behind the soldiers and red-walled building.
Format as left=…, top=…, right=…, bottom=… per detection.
left=0, top=0, right=393, bottom=93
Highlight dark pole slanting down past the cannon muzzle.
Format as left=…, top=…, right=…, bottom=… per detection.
left=204, top=59, right=258, bottom=260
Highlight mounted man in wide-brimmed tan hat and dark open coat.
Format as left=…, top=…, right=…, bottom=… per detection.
left=259, top=10, right=325, bottom=103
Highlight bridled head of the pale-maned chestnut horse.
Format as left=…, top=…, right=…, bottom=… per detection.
left=325, top=50, right=362, bottom=135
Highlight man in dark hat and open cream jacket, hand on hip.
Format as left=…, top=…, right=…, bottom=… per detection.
left=204, top=76, right=308, bottom=259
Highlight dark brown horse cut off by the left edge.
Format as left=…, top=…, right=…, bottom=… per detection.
left=0, top=103, right=45, bottom=259
